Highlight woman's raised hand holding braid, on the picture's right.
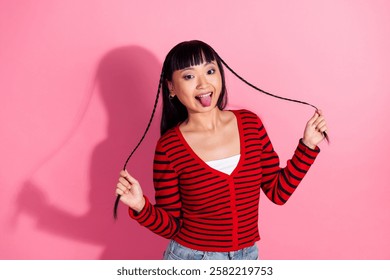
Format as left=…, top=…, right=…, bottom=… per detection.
left=302, top=110, right=328, bottom=149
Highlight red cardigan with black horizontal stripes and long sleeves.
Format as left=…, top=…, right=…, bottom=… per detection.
left=129, top=110, right=319, bottom=252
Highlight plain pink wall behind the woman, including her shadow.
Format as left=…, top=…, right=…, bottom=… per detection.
left=0, top=0, right=390, bottom=259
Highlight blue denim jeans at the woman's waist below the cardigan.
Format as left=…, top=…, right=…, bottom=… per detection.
left=163, top=240, right=258, bottom=260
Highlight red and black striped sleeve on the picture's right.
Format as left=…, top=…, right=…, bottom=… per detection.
left=259, top=119, right=320, bottom=205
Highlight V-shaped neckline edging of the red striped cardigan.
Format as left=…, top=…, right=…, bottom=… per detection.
left=175, top=110, right=245, bottom=177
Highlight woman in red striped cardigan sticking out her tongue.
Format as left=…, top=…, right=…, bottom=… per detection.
left=116, top=41, right=327, bottom=259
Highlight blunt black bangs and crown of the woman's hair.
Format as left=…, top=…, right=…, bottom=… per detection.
left=165, top=40, right=217, bottom=80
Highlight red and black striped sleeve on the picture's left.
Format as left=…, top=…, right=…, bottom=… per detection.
left=129, top=142, right=181, bottom=238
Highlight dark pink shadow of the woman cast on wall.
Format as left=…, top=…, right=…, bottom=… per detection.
left=14, top=46, right=167, bottom=259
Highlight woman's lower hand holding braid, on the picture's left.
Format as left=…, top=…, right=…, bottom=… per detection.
left=116, top=170, right=145, bottom=212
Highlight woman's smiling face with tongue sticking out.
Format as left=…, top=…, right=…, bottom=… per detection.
left=168, top=61, right=222, bottom=114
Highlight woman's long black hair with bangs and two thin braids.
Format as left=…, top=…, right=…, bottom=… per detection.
left=114, top=40, right=329, bottom=219
